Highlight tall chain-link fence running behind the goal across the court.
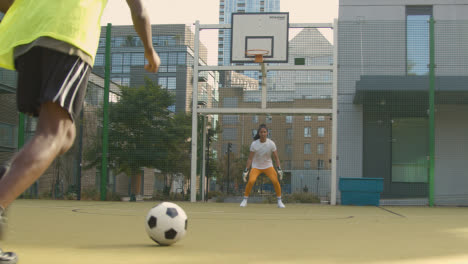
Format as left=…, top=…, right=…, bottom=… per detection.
left=0, top=18, right=468, bottom=204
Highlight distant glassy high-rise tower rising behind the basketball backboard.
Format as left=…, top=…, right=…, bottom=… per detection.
left=218, top=0, right=280, bottom=65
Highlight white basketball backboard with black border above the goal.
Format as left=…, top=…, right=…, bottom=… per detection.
left=231, top=12, right=289, bottom=63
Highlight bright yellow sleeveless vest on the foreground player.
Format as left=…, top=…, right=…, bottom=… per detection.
left=0, top=0, right=107, bottom=70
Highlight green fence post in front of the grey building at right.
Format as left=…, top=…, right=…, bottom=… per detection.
left=429, top=17, right=435, bottom=207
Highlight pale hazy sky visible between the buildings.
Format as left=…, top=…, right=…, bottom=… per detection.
left=101, top=0, right=339, bottom=64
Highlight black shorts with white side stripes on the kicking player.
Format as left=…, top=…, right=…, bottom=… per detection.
left=15, top=47, right=91, bottom=121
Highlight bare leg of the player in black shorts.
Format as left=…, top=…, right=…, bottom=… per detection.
left=0, top=102, right=76, bottom=208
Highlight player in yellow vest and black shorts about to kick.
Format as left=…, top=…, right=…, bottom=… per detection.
left=0, top=0, right=160, bottom=264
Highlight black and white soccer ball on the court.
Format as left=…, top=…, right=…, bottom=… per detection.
left=145, top=202, right=187, bottom=246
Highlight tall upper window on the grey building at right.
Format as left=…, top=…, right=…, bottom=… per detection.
left=406, top=6, right=432, bottom=75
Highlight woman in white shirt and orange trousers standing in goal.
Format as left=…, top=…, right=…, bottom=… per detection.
left=240, top=124, right=285, bottom=208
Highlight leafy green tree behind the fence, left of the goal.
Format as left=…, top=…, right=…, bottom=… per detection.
left=85, top=79, right=191, bottom=197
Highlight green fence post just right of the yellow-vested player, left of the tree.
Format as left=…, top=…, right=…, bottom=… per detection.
left=101, top=23, right=112, bottom=201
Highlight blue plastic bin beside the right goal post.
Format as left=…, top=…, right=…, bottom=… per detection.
left=339, top=178, right=383, bottom=206
